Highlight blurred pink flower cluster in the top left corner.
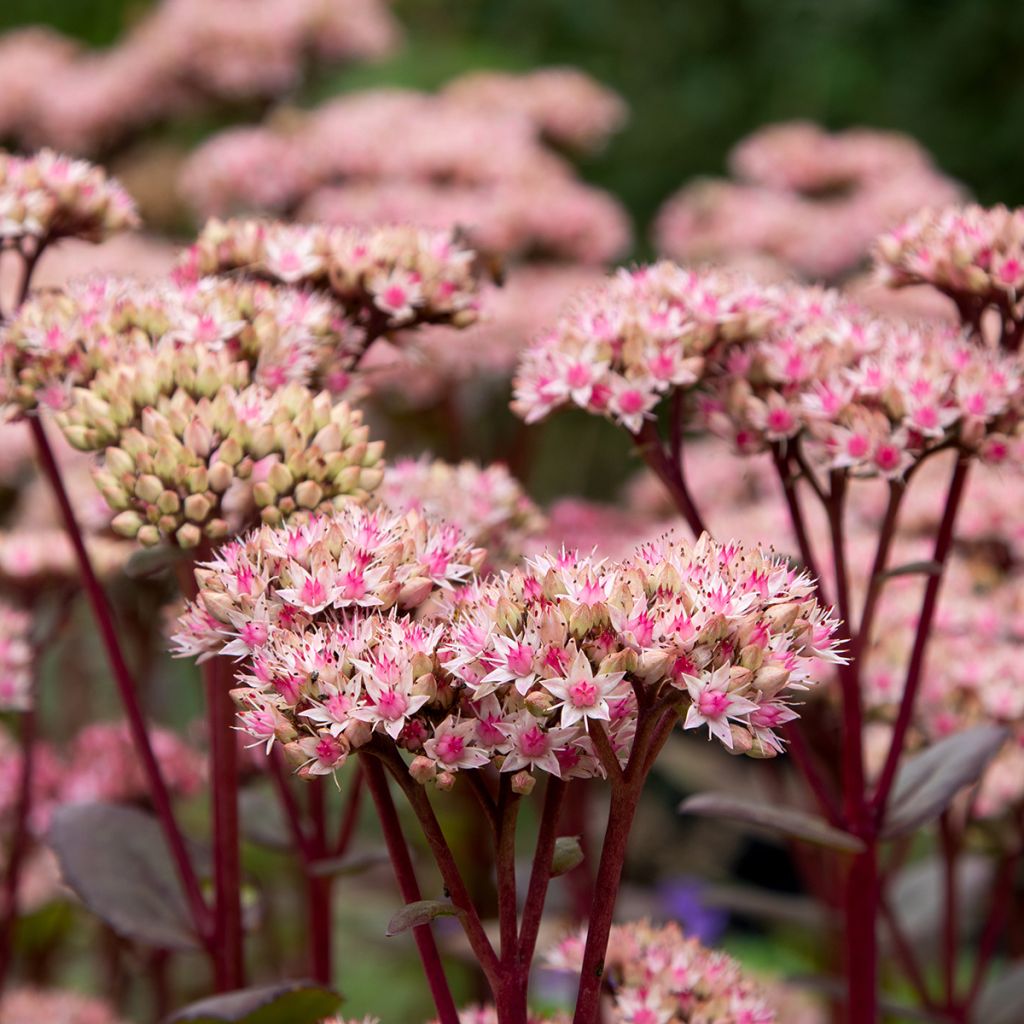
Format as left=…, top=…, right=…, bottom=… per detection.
left=0, top=0, right=398, bottom=153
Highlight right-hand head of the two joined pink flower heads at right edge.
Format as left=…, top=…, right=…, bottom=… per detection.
left=699, top=280, right=1024, bottom=478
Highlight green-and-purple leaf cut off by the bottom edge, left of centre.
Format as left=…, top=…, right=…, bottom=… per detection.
left=165, top=981, right=341, bottom=1024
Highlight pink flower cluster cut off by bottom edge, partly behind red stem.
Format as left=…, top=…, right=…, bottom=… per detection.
left=547, top=921, right=778, bottom=1024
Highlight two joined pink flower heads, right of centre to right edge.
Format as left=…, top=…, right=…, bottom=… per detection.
left=520, top=262, right=1022, bottom=477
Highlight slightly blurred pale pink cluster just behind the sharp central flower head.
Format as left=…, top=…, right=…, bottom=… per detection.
left=374, top=457, right=544, bottom=564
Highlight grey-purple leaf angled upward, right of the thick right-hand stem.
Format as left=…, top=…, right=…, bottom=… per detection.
left=882, top=725, right=1008, bottom=839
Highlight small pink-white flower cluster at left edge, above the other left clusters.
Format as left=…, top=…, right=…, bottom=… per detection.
left=0, top=150, right=138, bottom=245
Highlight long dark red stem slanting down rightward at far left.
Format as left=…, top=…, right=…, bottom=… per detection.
left=29, top=417, right=213, bottom=949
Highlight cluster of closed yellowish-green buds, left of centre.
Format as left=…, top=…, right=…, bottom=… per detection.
left=56, top=344, right=383, bottom=548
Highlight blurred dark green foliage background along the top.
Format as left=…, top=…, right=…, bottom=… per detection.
left=0, top=0, right=1024, bottom=256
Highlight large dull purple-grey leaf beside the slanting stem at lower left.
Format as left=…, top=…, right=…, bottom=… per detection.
left=48, top=804, right=200, bottom=949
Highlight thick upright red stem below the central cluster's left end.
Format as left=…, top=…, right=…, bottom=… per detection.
left=203, top=657, right=245, bottom=992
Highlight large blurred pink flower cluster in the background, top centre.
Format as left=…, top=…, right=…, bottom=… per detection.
left=181, top=82, right=630, bottom=262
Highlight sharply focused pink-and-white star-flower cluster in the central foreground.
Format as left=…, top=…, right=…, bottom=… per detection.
left=175, top=507, right=840, bottom=778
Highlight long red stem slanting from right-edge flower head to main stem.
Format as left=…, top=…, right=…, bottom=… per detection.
left=872, top=459, right=970, bottom=824
